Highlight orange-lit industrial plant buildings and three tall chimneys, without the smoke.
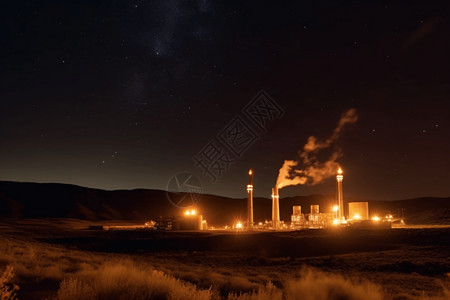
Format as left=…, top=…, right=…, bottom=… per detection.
left=121, top=167, right=396, bottom=231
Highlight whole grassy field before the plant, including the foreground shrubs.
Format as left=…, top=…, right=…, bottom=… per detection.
left=0, top=219, right=450, bottom=299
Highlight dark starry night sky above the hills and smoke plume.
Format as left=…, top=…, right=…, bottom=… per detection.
left=0, top=0, right=450, bottom=200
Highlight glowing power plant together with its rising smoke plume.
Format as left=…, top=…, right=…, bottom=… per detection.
left=125, top=109, right=392, bottom=231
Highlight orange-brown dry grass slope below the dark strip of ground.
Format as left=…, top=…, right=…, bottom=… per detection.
left=0, top=219, right=450, bottom=300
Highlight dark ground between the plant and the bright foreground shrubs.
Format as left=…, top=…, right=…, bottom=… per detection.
left=0, top=220, right=450, bottom=299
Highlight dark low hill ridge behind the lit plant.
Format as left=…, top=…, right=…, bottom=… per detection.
left=0, top=181, right=450, bottom=225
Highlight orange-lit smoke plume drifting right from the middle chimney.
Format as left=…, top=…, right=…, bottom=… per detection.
left=277, top=108, right=358, bottom=189
